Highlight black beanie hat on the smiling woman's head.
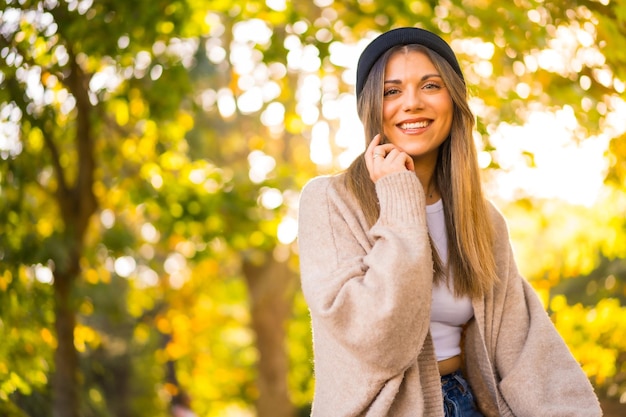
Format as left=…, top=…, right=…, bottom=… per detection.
left=356, top=27, right=464, bottom=98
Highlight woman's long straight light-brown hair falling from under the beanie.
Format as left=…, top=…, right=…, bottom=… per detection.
left=346, top=45, right=498, bottom=298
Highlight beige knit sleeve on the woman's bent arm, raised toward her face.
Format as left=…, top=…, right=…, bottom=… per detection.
left=299, top=172, right=433, bottom=380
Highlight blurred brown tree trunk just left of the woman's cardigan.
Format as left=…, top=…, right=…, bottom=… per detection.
left=243, top=253, right=296, bottom=417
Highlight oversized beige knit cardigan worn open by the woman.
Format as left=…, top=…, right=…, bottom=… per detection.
left=299, top=171, right=602, bottom=417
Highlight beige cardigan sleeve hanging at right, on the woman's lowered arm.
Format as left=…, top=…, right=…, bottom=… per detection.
left=494, top=206, right=602, bottom=417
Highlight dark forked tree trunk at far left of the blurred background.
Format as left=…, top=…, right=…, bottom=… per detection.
left=48, top=49, right=98, bottom=417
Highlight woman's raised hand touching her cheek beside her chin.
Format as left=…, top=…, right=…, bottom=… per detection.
left=365, top=134, right=415, bottom=182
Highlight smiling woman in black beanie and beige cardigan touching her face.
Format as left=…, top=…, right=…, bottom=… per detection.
left=299, top=28, right=601, bottom=417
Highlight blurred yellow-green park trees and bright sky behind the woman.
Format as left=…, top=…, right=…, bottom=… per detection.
left=0, top=0, right=626, bottom=417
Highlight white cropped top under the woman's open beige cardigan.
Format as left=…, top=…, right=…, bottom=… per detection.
left=426, top=200, right=474, bottom=361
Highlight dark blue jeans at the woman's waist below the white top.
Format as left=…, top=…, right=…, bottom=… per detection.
left=441, top=371, right=482, bottom=417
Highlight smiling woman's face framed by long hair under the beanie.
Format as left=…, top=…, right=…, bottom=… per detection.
left=383, top=50, right=453, bottom=161
